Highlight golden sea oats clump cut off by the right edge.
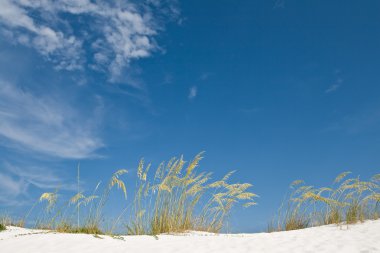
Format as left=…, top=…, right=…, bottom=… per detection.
left=268, top=172, right=380, bottom=231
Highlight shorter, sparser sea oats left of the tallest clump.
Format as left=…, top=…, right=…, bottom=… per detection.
left=24, top=167, right=127, bottom=234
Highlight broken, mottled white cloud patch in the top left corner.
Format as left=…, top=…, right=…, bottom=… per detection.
left=0, top=0, right=179, bottom=80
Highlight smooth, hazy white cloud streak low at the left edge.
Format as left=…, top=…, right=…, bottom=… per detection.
left=0, top=81, right=102, bottom=159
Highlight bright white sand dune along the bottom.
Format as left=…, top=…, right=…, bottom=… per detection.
left=0, top=220, right=380, bottom=253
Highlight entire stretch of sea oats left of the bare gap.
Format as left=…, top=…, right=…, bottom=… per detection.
left=17, top=153, right=257, bottom=235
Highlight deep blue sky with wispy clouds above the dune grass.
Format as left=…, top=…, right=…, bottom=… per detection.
left=0, top=0, right=380, bottom=232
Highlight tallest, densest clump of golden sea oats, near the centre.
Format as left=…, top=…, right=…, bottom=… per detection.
left=127, top=153, right=257, bottom=235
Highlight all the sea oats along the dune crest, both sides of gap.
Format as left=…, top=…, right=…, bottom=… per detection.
left=5, top=153, right=380, bottom=235
